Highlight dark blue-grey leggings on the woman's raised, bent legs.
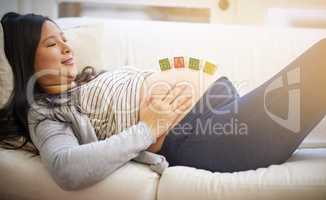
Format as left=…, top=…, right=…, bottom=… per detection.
left=158, top=40, right=326, bottom=172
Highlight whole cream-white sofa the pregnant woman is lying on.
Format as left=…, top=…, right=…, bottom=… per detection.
left=0, top=18, right=326, bottom=200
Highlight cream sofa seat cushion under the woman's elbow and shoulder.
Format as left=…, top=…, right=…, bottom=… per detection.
left=0, top=148, right=159, bottom=200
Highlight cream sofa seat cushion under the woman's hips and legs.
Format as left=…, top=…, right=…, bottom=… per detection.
left=158, top=148, right=326, bottom=200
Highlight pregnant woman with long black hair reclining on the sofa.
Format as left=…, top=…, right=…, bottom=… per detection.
left=0, top=13, right=326, bottom=190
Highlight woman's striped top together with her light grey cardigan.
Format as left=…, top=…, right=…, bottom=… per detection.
left=28, top=67, right=168, bottom=190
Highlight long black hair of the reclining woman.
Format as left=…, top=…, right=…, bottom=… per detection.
left=0, top=12, right=96, bottom=155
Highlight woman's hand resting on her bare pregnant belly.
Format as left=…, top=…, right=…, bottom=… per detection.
left=139, top=85, right=192, bottom=138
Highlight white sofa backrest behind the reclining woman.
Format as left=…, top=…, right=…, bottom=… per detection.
left=57, top=18, right=326, bottom=147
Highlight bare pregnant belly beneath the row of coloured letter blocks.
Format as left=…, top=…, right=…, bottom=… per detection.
left=140, top=68, right=220, bottom=127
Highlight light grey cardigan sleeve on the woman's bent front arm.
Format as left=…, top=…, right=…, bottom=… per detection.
left=30, top=112, right=156, bottom=190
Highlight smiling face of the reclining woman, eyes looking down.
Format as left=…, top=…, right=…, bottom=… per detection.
left=34, top=20, right=77, bottom=88
